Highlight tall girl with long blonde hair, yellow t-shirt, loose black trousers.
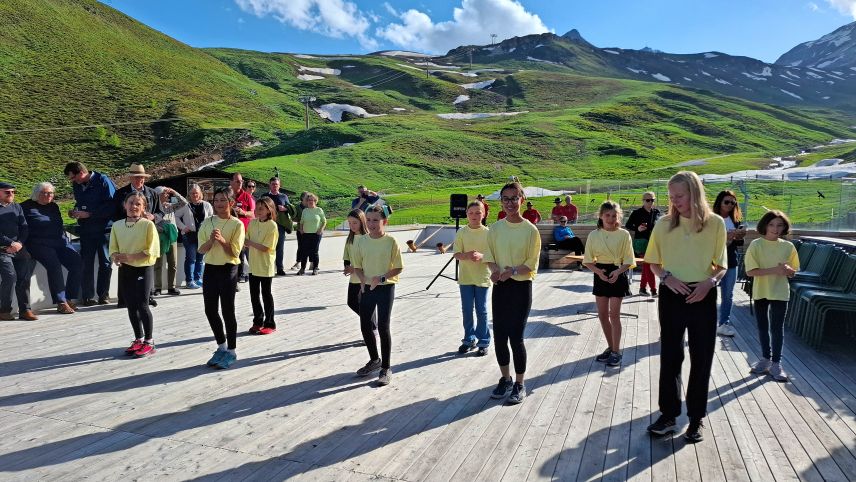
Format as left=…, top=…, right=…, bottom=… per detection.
left=645, top=171, right=728, bottom=443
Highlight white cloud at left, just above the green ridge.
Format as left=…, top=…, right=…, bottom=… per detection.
left=235, top=0, right=377, bottom=49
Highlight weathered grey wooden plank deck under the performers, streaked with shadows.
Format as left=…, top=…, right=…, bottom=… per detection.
left=0, top=253, right=856, bottom=481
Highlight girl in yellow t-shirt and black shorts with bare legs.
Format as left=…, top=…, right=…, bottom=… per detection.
left=583, top=201, right=636, bottom=367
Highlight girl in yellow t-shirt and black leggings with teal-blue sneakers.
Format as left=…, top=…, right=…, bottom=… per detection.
left=199, top=188, right=244, bottom=368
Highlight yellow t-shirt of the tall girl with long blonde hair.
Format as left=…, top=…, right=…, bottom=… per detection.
left=645, top=216, right=728, bottom=283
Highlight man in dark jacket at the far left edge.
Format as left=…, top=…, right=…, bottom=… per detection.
left=0, top=182, right=39, bottom=321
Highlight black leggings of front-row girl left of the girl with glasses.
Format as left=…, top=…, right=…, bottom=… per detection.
left=360, top=284, right=395, bottom=368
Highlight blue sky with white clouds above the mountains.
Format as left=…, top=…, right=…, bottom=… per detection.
left=103, top=0, right=856, bottom=62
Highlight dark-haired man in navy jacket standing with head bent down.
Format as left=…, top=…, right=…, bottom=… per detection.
left=63, top=162, right=116, bottom=306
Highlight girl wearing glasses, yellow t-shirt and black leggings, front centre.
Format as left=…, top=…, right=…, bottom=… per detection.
left=482, top=182, right=541, bottom=404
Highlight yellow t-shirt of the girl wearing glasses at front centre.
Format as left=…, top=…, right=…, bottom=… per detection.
left=483, top=219, right=541, bottom=281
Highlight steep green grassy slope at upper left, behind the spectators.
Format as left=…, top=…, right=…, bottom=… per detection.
left=0, top=0, right=300, bottom=182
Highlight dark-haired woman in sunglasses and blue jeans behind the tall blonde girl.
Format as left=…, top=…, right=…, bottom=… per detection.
left=713, top=191, right=746, bottom=336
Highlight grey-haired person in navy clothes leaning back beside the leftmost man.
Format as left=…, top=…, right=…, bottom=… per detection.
left=21, top=182, right=83, bottom=315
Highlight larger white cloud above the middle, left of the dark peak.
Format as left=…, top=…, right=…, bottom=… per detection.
left=378, top=0, right=550, bottom=53
